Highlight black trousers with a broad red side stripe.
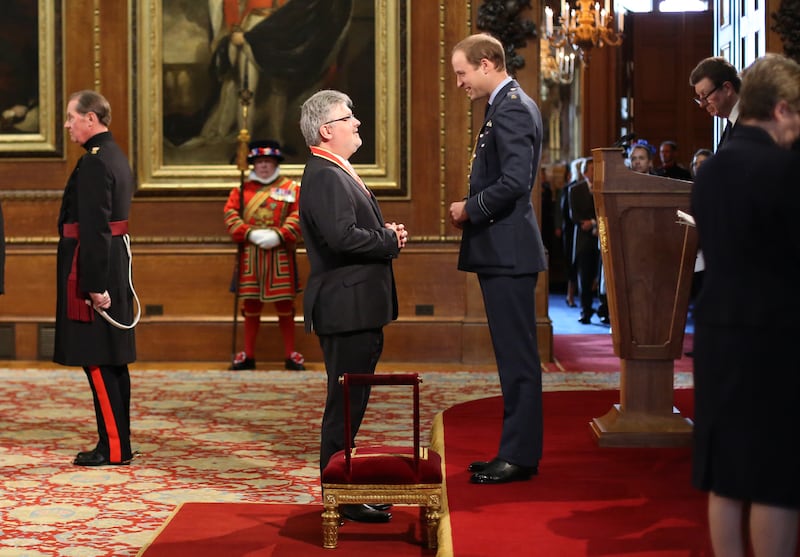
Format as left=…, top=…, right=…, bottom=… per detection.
left=83, top=365, right=133, bottom=462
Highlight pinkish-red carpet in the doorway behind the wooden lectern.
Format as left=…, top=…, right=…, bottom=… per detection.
left=545, top=334, right=694, bottom=371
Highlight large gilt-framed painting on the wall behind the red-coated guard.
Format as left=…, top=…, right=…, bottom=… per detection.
left=136, top=0, right=407, bottom=197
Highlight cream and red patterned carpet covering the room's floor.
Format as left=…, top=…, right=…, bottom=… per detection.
left=0, top=366, right=691, bottom=557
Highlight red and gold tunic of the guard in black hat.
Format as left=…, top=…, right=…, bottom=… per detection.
left=225, top=176, right=301, bottom=302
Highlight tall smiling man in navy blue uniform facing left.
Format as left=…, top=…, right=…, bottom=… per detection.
left=450, top=34, right=547, bottom=484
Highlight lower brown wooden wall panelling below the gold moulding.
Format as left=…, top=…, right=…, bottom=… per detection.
left=0, top=240, right=468, bottom=361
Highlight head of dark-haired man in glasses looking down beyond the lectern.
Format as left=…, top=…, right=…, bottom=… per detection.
left=689, top=56, right=742, bottom=149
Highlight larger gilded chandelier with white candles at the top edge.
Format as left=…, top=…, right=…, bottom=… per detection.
left=544, top=0, right=624, bottom=64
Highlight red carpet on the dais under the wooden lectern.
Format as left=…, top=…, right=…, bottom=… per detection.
left=443, top=390, right=711, bottom=557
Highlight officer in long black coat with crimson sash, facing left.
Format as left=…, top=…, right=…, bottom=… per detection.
left=53, top=91, right=136, bottom=466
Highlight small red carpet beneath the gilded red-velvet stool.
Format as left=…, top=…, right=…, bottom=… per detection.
left=139, top=503, right=435, bottom=557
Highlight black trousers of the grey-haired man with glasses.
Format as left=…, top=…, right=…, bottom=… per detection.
left=319, top=329, right=383, bottom=473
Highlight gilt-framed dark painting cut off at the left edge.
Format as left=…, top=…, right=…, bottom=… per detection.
left=0, top=0, right=64, bottom=158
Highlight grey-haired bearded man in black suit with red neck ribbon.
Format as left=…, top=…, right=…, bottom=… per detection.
left=300, top=90, right=408, bottom=522
